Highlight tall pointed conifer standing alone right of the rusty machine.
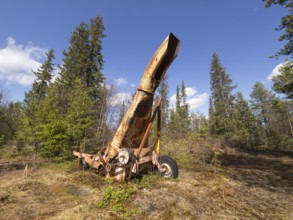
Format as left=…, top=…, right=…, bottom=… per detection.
left=209, top=53, right=236, bottom=135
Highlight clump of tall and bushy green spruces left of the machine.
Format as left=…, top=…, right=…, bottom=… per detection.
left=17, top=17, right=105, bottom=158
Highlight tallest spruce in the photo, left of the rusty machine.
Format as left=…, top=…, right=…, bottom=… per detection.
left=57, top=16, right=106, bottom=151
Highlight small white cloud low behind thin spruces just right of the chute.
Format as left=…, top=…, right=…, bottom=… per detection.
left=169, top=87, right=209, bottom=111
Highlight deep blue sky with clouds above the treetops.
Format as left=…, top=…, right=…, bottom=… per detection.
left=0, top=0, right=287, bottom=113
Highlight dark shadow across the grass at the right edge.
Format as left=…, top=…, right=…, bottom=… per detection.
left=220, top=153, right=293, bottom=193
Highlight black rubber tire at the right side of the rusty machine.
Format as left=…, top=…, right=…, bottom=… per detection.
left=159, top=156, right=179, bottom=179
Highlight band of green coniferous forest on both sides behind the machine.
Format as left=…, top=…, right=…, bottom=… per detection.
left=0, top=10, right=293, bottom=158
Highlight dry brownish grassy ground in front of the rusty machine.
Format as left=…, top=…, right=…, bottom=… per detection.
left=0, top=149, right=293, bottom=220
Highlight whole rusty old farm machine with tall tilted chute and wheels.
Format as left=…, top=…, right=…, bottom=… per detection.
left=73, top=33, right=180, bottom=182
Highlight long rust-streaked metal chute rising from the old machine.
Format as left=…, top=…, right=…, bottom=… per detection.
left=104, top=33, right=179, bottom=162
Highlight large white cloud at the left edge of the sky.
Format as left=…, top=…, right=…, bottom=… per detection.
left=0, top=37, right=47, bottom=86
